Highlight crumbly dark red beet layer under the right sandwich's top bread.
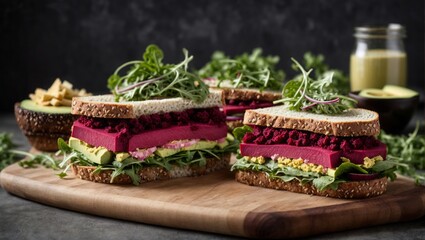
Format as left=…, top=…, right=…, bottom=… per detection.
left=242, top=126, right=379, bottom=151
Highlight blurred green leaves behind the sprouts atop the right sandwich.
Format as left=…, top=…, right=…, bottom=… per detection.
left=291, top=52, right=350, bottom=95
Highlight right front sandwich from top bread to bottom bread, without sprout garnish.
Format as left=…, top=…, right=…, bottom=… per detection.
left=232, top=106, right=395, bottom=198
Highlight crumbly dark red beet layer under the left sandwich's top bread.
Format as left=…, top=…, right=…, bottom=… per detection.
left=77, top=107, right=226, bottom=137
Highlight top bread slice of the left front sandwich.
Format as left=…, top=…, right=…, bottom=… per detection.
left=71, top=91, right=223, bottom=118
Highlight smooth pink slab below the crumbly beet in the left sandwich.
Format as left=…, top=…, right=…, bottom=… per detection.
left=71, top=121, right=227, bottom=152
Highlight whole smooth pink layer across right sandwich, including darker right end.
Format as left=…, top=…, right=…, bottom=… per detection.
left=240, top=143, right=387, bottom=168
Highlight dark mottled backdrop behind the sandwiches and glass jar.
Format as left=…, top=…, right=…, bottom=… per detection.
left=0, top=0, right=425, bottom=112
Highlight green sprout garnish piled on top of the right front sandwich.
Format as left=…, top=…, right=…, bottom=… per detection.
left=274, top=58, right=356, bottom=114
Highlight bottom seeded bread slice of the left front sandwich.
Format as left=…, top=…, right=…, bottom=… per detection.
left=71, top=154, right=230, bottom=184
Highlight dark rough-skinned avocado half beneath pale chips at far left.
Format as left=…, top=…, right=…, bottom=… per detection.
left=15, top=99, right=77, bottom=152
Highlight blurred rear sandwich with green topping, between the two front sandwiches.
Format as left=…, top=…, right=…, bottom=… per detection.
left=199, top=48, right=285, bottom=131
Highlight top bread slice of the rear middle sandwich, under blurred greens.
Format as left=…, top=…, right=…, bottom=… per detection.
left=210, top=87, right=282, bottom=102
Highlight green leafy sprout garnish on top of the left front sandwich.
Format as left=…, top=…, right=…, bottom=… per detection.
left=108, top=45, right=209, bottom=103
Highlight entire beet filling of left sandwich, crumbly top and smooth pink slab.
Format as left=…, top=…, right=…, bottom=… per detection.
left=71, top=107, right=227, bottom=152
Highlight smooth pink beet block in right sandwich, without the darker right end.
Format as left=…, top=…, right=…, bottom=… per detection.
left=240, top=143, right=341, bottom=168
